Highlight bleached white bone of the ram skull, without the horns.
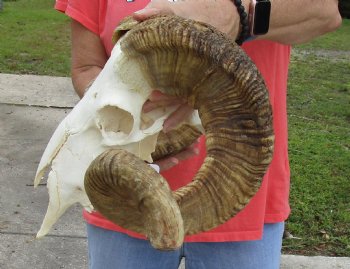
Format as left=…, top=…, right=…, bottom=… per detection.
left=34, top=39, right=200, bottom=238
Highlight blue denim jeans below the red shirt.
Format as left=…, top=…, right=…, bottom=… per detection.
left=87, top=222, right=284, bottom=269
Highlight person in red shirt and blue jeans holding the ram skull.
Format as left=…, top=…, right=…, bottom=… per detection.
left=55, top=0, right=341, bottom=269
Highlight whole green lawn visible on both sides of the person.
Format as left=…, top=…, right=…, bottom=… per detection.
left=0, top=0, right=350, bottom=256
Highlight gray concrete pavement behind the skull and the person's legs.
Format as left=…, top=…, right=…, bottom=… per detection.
left=0, top=74, right=350, bottom=269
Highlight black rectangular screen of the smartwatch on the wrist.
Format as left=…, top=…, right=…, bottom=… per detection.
left=253, top=1, right=271, bottom=35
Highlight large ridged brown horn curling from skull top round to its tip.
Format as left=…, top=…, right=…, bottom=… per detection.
left=85, top=16, right=274, bottom=249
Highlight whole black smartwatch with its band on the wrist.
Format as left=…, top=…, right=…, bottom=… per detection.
left=249, top=0, right=271, bottom=36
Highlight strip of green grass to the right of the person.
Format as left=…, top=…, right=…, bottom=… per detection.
left=283, top=21, right=350, bottom=256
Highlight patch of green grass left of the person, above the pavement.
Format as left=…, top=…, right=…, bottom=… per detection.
left=0, top=0, right=70, bottom=76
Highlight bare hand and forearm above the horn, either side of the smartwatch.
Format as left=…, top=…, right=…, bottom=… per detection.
left=134, top=0, right=341, bottom=44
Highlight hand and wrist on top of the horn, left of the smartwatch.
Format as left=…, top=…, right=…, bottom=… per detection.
left=133, top=0, right=249, bottom=40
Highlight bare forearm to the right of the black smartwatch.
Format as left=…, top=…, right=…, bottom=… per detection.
left=258, top=0, right=341, bottom=44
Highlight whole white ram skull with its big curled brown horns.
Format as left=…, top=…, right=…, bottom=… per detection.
left=35, top=16, right=274, bottom=249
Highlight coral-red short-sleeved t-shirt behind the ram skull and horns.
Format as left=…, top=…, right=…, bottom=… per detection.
left=55, top=0, right=290, bottom=242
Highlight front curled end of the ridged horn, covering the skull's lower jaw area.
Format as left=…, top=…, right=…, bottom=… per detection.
left=85, top=149, right=184, bottom=250
